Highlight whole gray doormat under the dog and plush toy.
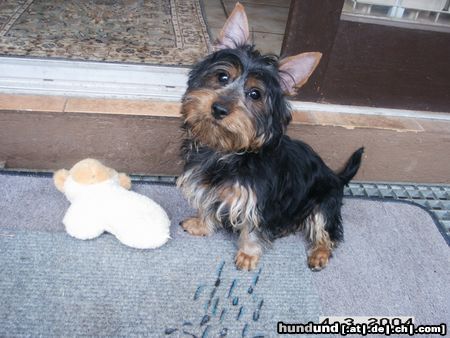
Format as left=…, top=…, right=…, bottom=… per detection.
left=0, top=173, right=450, bottom=337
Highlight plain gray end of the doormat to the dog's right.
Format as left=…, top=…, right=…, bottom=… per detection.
left=314, top=198, right=450, bottom=325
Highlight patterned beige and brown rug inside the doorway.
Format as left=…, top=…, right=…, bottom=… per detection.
left=0, top=0, right=209, bottom=65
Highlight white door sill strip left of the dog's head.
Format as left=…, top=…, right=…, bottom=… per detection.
left=0, top=57, right=189, bottom=101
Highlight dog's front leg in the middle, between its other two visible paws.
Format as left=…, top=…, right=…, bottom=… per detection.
left=235, top=226, right=262, bottom=271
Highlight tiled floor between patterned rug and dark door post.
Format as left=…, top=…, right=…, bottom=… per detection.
left=204, top=0, right=290, bottom=54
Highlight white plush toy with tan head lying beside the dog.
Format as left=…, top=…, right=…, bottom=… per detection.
left=53, top=159, right=170, bottom=249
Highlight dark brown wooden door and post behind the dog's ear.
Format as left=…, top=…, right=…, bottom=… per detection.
left=281, top=0, right=450, bottom=112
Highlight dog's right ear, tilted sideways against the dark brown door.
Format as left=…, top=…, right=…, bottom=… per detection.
left=279, top=52, right=322, bottom=96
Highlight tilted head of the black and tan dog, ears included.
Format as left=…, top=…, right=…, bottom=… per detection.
left=181, top=3, right=322, bottom=152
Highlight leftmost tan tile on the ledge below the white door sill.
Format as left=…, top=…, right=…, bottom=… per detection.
left=0, top=94, right=66, bottom=112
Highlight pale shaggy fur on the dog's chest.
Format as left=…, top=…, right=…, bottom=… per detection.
left=177, top=166, right=259, bottom=228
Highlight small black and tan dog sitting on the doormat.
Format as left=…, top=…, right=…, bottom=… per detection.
left=177, top=3, right=363, bottom=270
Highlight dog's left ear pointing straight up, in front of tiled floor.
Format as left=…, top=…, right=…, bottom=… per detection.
left=215, top=2, right=250, bottom=50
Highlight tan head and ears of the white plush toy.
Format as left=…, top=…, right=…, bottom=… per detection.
left=53, top=158, right=131, bottom=192
